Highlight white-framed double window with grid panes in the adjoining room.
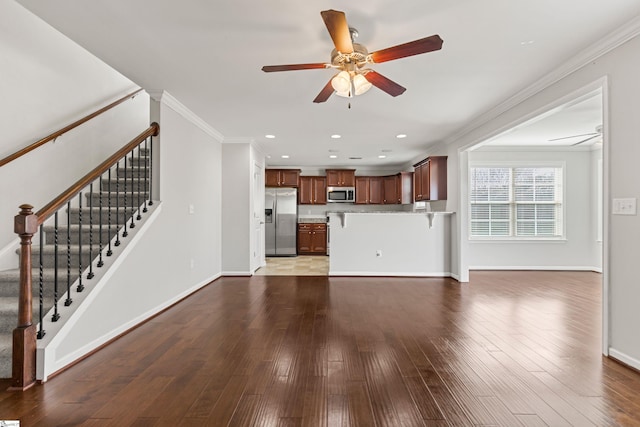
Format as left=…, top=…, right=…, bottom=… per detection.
left=469, top=165, right=564, bottom=239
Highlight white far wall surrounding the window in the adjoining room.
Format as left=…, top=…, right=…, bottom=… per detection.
left=467, top=149, right=602, bottom=271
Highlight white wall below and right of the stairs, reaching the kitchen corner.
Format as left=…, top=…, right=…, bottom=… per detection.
left=38, top=94, right=223, bottom=378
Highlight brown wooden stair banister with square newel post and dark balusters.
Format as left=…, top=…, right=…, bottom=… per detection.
left=10, top=122, right=160, bottom=390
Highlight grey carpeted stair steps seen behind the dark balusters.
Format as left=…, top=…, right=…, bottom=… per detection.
left=0, top=148, right=150, bottom=378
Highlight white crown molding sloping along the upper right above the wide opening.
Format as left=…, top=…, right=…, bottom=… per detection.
left=444, top=16, right=640, bottom=145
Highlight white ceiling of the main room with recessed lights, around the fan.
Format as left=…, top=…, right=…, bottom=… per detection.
left=19, top=0, right=640, bottom=167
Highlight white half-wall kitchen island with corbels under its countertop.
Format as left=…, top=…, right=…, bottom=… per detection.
left=328, top=212, right=453, bottom=277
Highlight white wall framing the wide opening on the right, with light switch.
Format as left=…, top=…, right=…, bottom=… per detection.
left=438, top=32, right=640, bottom=369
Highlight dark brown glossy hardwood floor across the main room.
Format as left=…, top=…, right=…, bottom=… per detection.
left=0, top=272, right=640, bottom=427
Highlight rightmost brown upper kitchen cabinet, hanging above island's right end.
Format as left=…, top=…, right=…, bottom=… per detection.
left=413, top=156, right=447, bottom=202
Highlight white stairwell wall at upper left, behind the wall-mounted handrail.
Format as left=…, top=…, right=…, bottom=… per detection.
left=0, top=0, right=149, bottom=270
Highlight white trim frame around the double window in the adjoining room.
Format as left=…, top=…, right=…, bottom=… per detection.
left=467, top=160, right=567, bottom=243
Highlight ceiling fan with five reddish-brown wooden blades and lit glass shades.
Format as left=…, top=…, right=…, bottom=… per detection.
left=262, top=10, right=442, bottom=103
